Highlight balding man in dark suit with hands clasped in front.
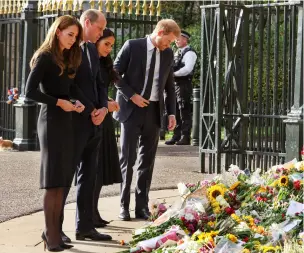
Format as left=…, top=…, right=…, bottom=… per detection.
left=61, top=9, right=112, bottom=242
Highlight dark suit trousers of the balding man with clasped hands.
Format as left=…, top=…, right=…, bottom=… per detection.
left=61, top=121, right=101, bottom=232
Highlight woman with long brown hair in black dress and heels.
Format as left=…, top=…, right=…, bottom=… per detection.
left=25, top=15, right=93, bottom=252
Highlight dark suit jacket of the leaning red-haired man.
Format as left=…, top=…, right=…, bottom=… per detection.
left=113, top=38, right=176, bottom=123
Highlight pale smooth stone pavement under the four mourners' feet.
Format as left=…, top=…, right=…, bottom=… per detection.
left=0, top=190, right=180, bottom=253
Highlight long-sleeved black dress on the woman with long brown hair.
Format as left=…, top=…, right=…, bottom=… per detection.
left=25, top=53, right=88, bottom=189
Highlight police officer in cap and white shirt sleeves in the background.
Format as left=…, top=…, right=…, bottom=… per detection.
left=165, top=31, right=197, bottom=145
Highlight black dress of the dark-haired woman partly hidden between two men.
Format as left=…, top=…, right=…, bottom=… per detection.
left=97, top=58, right=122, bottom=186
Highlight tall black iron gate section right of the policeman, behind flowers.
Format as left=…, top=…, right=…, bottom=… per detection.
left=200, top=1, right=303, bottom=173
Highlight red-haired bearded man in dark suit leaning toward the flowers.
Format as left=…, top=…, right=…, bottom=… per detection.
left=113, top=19, right=180, bottom=220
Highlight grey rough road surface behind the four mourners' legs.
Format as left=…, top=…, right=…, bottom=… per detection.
left=0, top=142, right=216, bottom=223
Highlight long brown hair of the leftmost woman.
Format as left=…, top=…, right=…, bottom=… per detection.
left=30, top=15, right=82, bottom=78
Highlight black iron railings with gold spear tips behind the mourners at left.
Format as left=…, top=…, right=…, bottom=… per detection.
left=0, top=0, right=160, bottom=149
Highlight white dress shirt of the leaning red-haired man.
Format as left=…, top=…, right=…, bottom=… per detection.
left=140, top=36, right=160, bottom=101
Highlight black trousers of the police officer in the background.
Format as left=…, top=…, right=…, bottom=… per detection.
left=174, top=80, right=192, bottom=138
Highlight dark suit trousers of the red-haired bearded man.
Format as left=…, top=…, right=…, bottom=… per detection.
left=120, top=102, right=160, bottom=210
